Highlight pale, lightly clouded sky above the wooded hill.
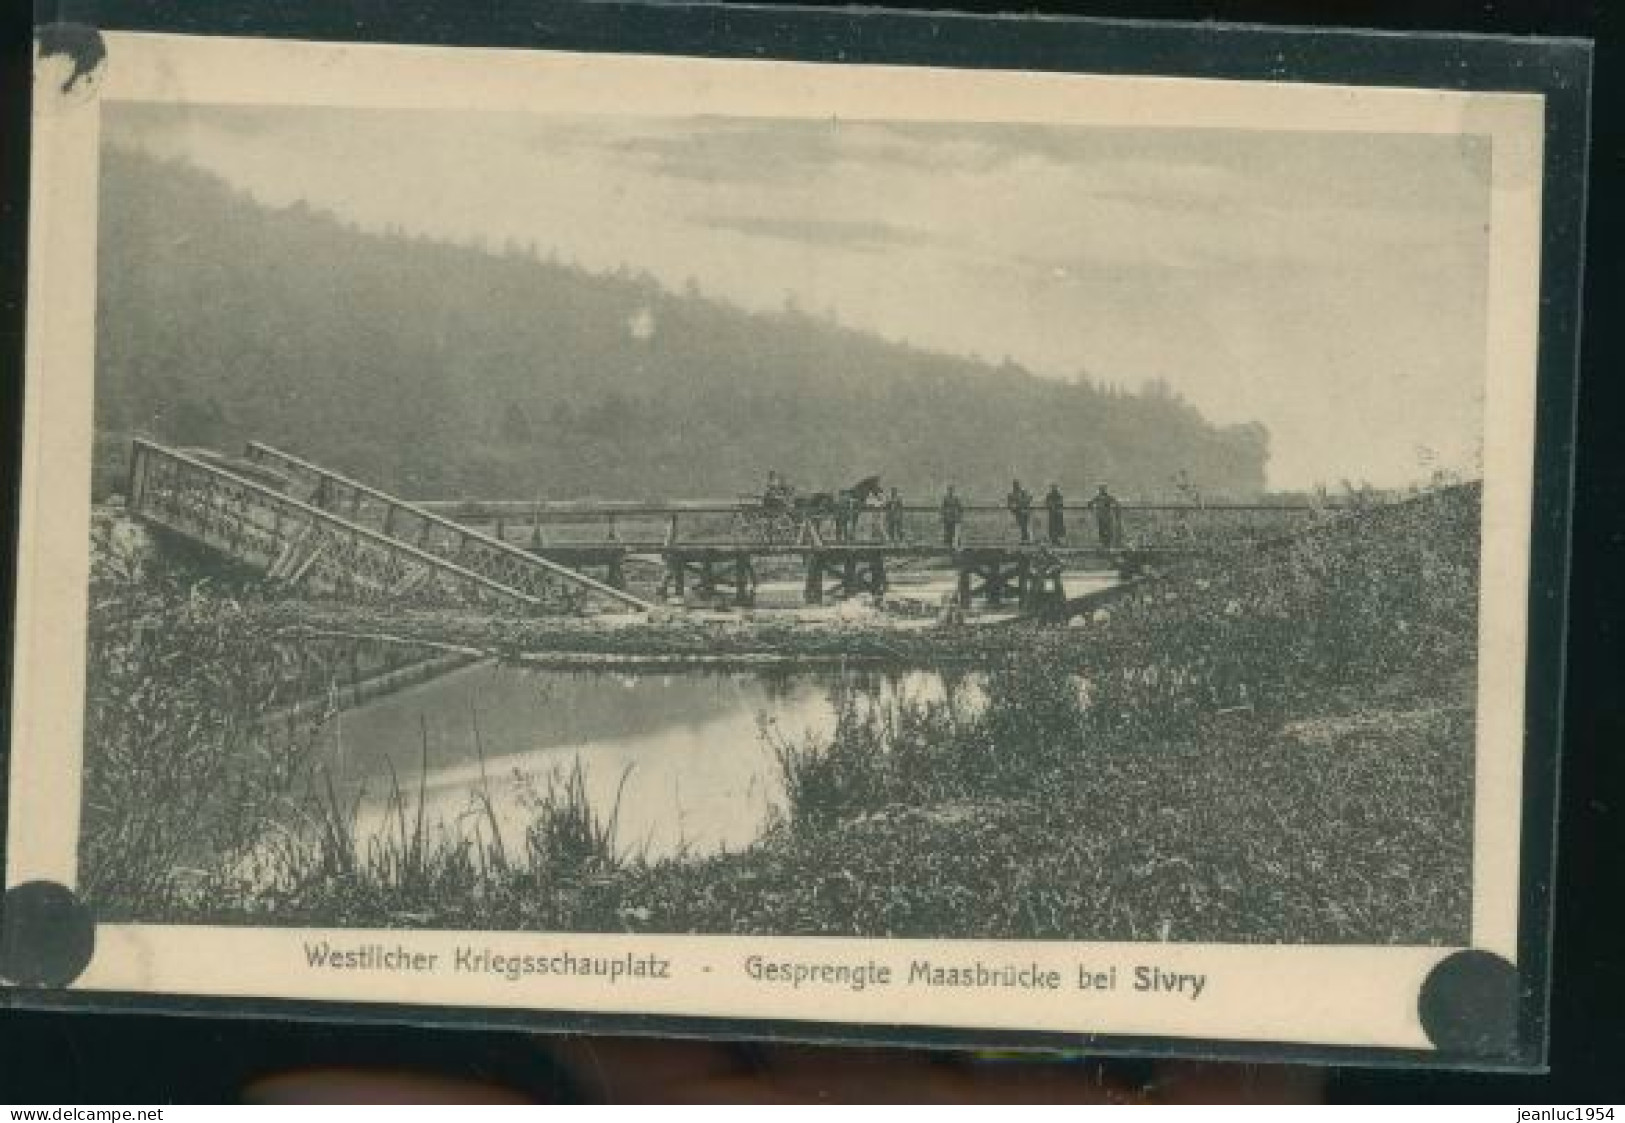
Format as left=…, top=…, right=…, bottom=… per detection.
left=104, top=102, right=1490, bottom=488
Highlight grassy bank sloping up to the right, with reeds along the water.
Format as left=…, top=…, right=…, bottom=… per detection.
left=85, top=488, right=1479, bottom=944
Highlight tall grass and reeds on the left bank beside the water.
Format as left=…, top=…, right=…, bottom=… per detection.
left=80, top=520, right=643, bottom=923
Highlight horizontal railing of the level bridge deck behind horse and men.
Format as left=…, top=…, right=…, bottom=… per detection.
left=418, top=501, right=1341, bottom=549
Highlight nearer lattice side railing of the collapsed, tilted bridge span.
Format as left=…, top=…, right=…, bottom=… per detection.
left=127, top=439, right=543, bottom=608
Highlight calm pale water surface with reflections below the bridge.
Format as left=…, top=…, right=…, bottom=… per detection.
left=323, top=665, right=982, bottom=860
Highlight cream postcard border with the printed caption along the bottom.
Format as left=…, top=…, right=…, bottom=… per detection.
left=7, top=33, right=1544, bottom=1048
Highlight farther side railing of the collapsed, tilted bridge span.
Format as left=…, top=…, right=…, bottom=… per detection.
left=238, top=440, right=652, bottom=609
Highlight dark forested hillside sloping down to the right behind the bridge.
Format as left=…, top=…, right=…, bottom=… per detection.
left=96, top=143, right=1269, bottom=502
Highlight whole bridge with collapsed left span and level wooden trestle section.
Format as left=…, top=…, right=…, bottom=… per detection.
left=128, top=440, right=1323, bottom=613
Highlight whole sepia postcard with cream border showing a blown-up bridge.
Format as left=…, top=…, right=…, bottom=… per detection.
left=10, top=24, right=1573, bottom=1066
